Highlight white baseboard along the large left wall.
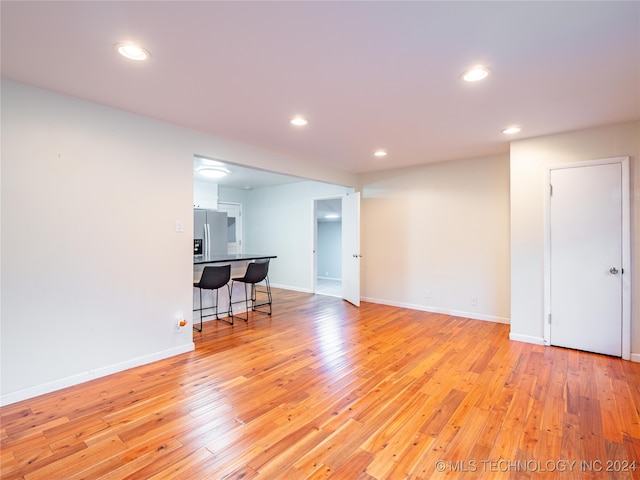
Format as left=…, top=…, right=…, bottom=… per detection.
left=0, top=342, right=196, bottom=406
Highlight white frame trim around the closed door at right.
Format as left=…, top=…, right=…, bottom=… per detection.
left=543, top=157, right=632, bottom=360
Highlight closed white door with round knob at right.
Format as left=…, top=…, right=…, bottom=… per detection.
left=549, top=163, right=623, bottom=356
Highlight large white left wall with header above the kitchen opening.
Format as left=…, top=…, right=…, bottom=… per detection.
left=0, top=80, right=355, bottom=404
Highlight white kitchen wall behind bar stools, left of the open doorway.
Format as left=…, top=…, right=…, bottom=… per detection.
left=243, top=181, right=353, bottom=292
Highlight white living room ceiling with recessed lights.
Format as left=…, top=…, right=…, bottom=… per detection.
left=1, top=0, right=640, bottom=178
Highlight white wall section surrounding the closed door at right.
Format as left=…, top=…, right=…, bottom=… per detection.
left=511, top=122, right=640, bottom=361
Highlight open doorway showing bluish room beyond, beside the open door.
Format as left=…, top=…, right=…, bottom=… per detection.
left=313, top=197, right=342, bottom=297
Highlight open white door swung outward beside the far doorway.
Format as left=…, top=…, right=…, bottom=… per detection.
left=342, top=193, right=362, bottom=307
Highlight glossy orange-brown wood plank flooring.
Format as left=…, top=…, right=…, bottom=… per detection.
left=0, top=290, right=640, bottom=480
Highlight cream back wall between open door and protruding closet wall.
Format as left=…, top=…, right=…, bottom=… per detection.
left=361, top=155, right=510, bottom=323
